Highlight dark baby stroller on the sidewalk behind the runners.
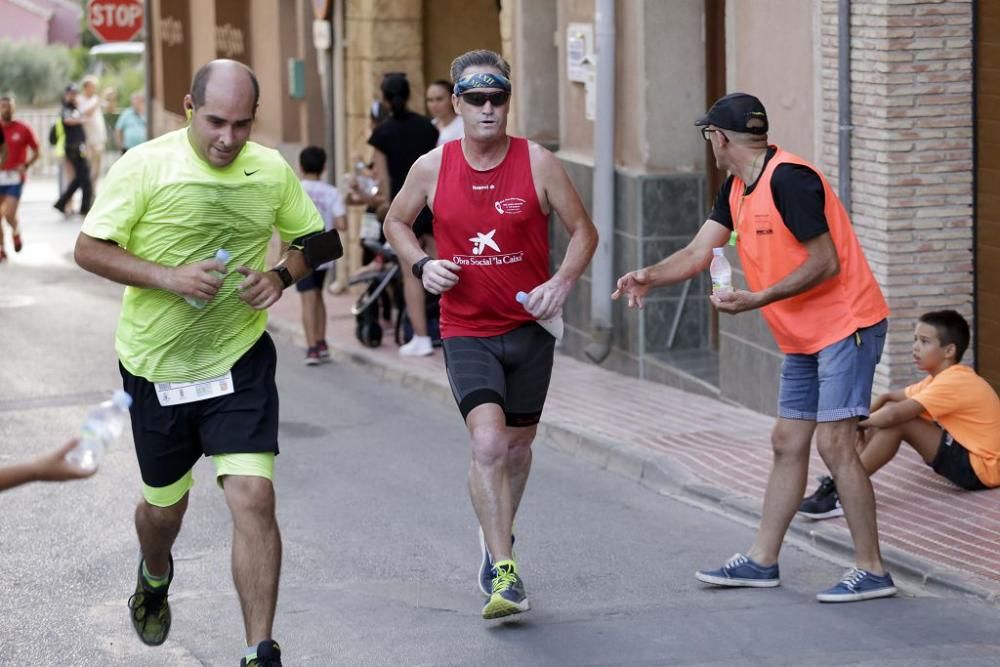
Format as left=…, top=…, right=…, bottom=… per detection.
left=349, top=239, right=441, bottom=347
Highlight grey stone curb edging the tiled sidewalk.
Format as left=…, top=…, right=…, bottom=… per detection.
left=267, top=316, right=1000, bottom=605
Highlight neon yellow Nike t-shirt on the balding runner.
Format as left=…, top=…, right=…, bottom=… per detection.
left=82, top=128, right=323, bottom=382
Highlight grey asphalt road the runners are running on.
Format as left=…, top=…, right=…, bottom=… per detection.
left=0, top=189, right=1000, bottom=666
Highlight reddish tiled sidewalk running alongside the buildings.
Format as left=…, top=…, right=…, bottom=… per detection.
left=269, top=290, right=1000, bottom=602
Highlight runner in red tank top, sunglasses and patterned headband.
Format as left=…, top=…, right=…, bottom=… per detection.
left=385, top=50, right=597, bottom=618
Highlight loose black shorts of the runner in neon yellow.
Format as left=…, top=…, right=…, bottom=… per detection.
left=118, top=332, right=278, bottom=487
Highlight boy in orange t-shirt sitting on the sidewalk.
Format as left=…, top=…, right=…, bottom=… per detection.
left=799, top=310, right=1000, bottom=519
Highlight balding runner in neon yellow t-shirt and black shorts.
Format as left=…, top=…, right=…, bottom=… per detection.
left=76, top=60, right=323, bottom=665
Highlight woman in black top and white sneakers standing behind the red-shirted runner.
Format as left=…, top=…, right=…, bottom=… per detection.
left=368, top=73, right=438, bottom=356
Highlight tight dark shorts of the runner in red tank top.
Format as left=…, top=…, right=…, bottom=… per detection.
left=444, top=322, right=556, bottom=426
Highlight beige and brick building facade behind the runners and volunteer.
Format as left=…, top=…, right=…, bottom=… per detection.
left=145, top=0, right=988, bottom=413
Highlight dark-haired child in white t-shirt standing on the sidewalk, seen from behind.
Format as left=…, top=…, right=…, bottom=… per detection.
left=295, top=146, right=347, bottom=366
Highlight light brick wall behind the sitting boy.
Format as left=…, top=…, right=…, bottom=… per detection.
left=818, top=0, right=973, bottom=391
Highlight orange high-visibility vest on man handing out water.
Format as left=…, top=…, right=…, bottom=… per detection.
left=729, top=148, right=889, bottom=354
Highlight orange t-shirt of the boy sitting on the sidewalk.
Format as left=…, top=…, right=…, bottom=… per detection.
left=905, top=364, right=1000, bottom=487
